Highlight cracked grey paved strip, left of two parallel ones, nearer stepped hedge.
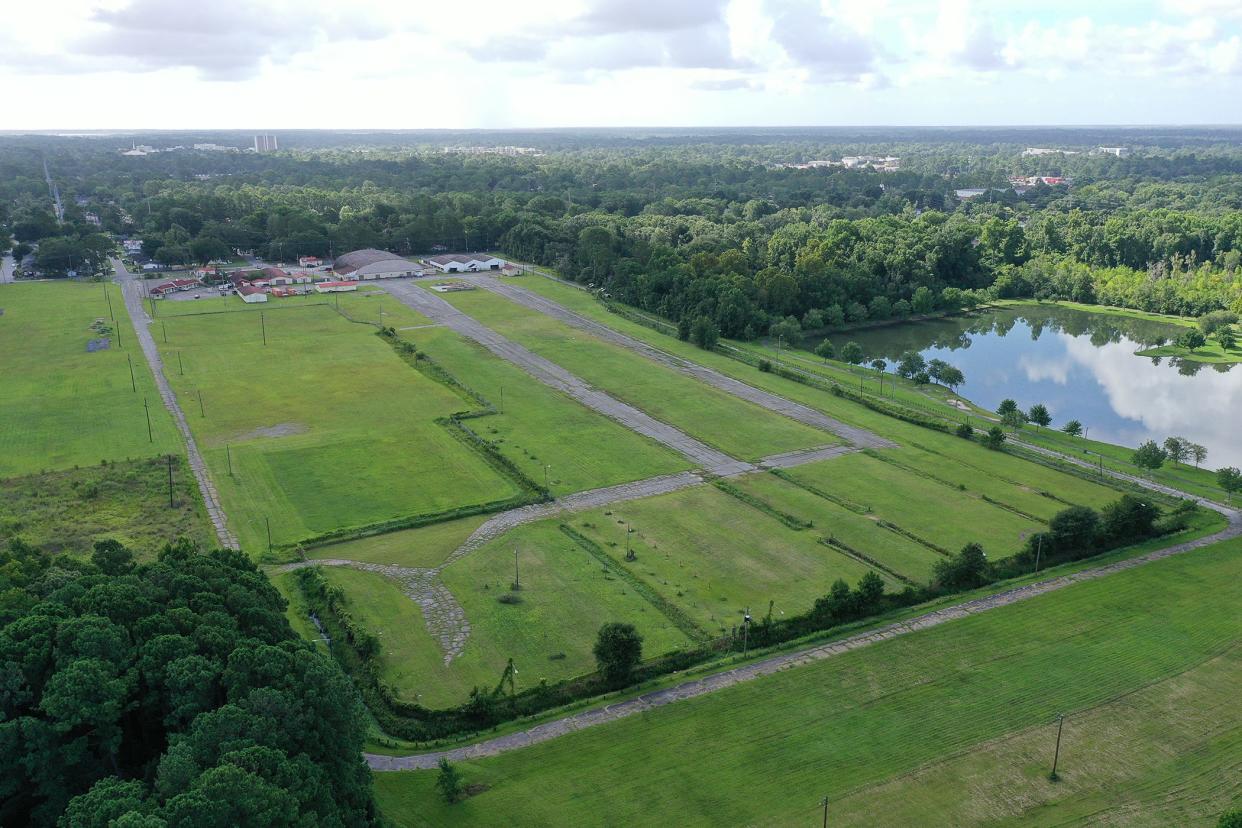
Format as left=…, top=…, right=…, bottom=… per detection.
left=383, top=282, right=754, bottom=474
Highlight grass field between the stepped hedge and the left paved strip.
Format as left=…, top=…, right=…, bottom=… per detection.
left=400, top=326, right=693, bottom=497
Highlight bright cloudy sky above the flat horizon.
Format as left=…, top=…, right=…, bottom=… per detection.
left=7, top=0, right=1242, bottom=129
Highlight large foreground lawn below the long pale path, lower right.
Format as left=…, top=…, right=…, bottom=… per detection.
left=375, top=540, right=1242, bottom=826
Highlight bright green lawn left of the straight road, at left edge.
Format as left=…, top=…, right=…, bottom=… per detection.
left=0, top=282, right=184, bottom=478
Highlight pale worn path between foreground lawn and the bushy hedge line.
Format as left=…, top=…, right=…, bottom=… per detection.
left=365, top=491, right=1242, bottom=771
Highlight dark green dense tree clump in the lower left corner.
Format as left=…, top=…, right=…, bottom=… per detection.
left=0, top=541, right=375, bottom=828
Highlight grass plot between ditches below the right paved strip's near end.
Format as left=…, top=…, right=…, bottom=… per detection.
left=787, top=454, right=1043, bottom=557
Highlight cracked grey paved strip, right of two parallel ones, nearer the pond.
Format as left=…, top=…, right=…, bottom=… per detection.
left=467, top=274, right=894, bottom=448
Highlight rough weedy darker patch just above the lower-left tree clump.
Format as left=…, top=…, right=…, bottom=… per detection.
left=0, top=457, right=215, bottom=559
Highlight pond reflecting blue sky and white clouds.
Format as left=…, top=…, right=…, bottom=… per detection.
left=806, top=304, right=1242, bottom=468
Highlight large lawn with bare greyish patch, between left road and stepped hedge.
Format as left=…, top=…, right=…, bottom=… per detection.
left=158, top=299, right=517, bottom=552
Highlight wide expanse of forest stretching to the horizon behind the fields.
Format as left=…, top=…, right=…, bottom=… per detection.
left=0, top=129, right=1242, bottom=338
